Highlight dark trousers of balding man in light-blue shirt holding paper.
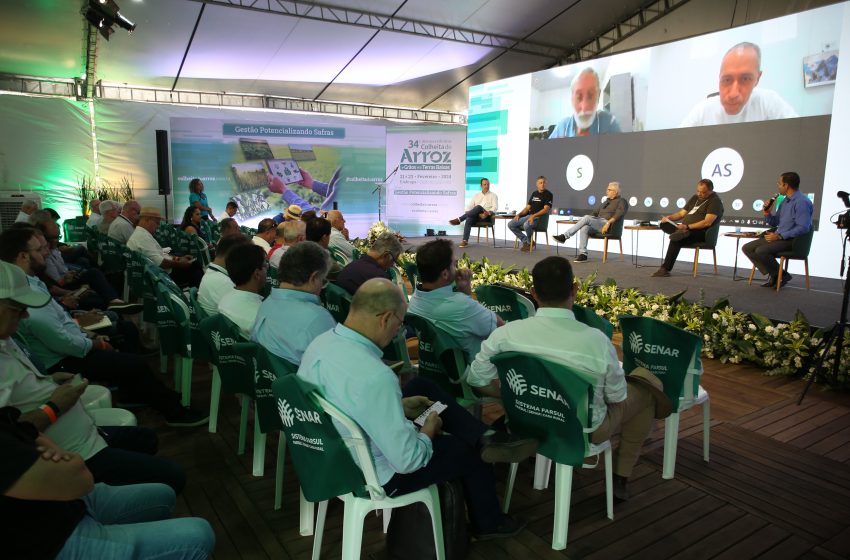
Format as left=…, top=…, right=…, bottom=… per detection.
left=384, top=377, right=502, bottom=533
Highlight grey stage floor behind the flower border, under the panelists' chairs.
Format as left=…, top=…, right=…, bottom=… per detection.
left=405, top=235, right=843, bottom=327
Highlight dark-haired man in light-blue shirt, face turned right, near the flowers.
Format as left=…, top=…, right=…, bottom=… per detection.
left=409, top=239, right=505, bottom=360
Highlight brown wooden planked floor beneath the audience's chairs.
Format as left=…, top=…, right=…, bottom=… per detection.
left=134, top=350, right=850, bottom=560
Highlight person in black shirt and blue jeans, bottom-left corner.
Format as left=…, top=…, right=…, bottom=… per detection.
left=0, top=407, right=215, bottom=560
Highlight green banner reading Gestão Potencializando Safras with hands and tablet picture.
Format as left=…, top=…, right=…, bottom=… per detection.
left=171, top=114, right=384, bottom=236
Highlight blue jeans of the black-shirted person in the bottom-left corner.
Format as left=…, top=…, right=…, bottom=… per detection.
left=57, top=484, right=215, bottom=560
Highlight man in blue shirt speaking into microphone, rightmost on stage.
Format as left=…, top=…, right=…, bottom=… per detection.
left=742, top=171, right=814, bottom=288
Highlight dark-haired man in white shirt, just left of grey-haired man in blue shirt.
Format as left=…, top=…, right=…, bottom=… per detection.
left=218, top=244, right=264, bottom=339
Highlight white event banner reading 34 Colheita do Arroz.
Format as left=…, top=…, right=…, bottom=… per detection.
left=385, top=127, right=466, bottom=235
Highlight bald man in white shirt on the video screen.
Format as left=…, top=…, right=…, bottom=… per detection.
left=680, top=42, right=798, bottom=127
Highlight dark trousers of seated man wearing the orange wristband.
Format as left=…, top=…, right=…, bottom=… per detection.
left=86, top=426, right=186, bottom=494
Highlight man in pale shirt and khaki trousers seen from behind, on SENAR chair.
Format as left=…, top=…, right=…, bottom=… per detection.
left=467, top=257, right=671, bottom=500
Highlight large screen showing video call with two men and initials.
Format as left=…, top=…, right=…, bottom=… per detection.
left=467, top=3, right=847, bottom=230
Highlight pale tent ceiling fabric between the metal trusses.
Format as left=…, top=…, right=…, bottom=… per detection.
left=0, top=0, right=704, bottom=112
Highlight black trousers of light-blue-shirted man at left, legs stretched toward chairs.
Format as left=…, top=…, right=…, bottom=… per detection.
left=49, top=350, right=182, bottom=419
